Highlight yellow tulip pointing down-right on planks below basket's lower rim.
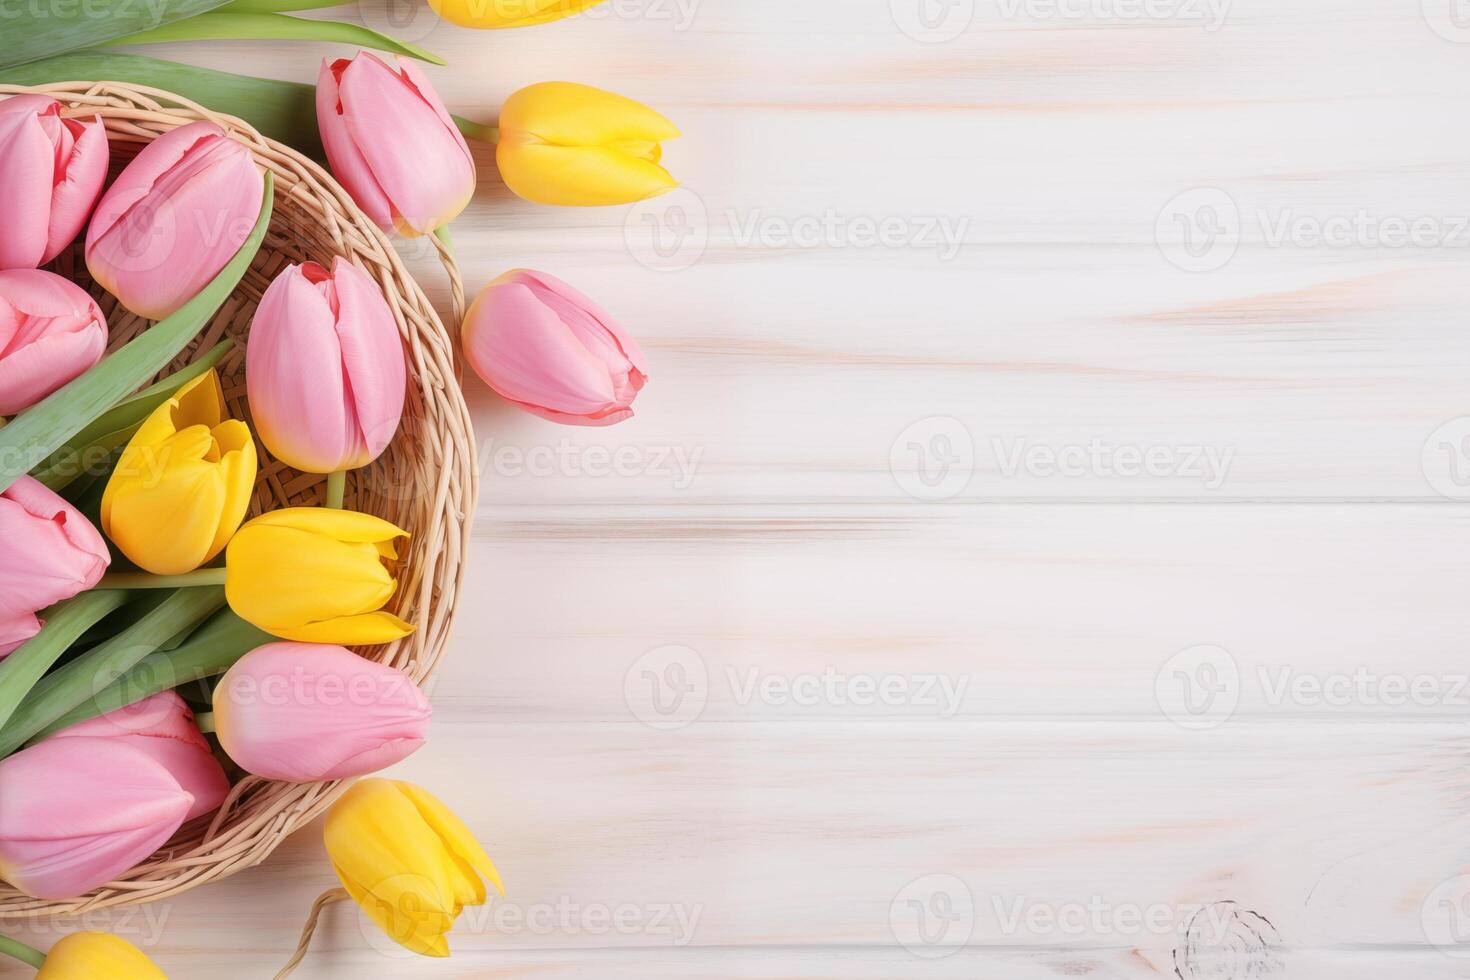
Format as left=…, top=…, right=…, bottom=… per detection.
left=325, top=779, right=506, bottom=956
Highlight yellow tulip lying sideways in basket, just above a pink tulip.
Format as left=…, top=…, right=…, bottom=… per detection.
left=225, top=507, right=413, bottom=646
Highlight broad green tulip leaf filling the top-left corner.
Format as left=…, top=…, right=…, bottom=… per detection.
left=0, top=0, right=235, bottom=68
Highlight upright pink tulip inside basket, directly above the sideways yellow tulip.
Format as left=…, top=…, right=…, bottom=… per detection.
left=245, top=256, right=406, bottom=473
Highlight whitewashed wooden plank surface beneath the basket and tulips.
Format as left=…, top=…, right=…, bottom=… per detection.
left=3, top=0, right=1470, bottom=980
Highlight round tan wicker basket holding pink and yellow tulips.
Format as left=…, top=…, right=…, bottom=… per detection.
left=0, top=82, right=478, bottom=920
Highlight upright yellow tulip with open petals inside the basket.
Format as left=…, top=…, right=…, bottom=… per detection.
left=101, top=370, right=257, bottom=574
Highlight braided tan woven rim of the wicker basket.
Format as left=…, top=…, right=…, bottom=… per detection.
left=0, top=81, right=479, bottom=920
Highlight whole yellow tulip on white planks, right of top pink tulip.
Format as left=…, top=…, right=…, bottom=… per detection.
left=495, top=82, right=679, bottom=206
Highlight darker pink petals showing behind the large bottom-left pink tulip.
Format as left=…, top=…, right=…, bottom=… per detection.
left=51, top=691, right=229, bottom=820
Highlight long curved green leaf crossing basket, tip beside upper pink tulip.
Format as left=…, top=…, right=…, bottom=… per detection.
left=0, top=170, right=275, bottom=491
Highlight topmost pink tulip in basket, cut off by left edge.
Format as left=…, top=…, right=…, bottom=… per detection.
left=0, top=96, right=107, bottom=270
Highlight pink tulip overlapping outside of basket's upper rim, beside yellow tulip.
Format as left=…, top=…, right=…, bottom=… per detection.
left=316, top=51, right=475, bottom=235
